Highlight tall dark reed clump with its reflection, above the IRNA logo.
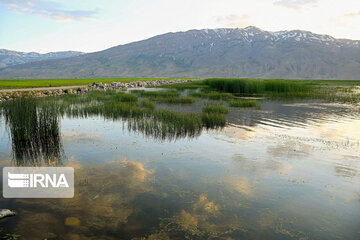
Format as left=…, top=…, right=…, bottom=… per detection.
left=2, top=98, right=63, bottom=166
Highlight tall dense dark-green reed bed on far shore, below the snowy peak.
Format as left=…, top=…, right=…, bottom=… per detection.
left=204, top=79, right=311, bottom=95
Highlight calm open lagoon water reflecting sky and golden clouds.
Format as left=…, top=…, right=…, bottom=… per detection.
left=0, top=97, right=360, bottom=240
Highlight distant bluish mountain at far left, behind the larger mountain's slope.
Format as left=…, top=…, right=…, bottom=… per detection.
left=0, top=49, right=84, bottom=68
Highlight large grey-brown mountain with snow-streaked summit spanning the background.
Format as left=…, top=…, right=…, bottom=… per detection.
left=0, top=27, right=360, bottom=79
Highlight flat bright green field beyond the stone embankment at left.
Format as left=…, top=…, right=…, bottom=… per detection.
left=0, top=78, right=184, bottom=89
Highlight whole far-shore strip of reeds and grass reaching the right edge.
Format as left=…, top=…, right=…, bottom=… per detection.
left=166, top=78, right=360, bottom=103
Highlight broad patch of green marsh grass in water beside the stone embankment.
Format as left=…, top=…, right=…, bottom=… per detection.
left=7, top=91, right=225, bottom=142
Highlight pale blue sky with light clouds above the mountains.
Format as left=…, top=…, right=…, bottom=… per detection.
left=0, top=0, right=360, bottom=53
